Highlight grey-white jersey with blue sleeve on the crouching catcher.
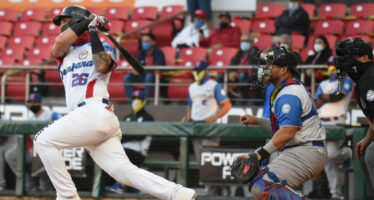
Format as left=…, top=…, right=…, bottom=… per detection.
left=271, top=81, right=326, bottom=146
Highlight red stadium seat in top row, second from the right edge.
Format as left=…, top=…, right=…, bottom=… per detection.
left=318, top=3, right=347, bottom=18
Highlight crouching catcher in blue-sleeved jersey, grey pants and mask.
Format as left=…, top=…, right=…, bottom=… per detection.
left=231, top=47, right=327, bottom=200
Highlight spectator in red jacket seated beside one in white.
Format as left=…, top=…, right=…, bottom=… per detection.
left=200, top=12, right=241, bottom=52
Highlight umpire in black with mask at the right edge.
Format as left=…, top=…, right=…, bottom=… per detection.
left=336, top=38, right=374, bottom=190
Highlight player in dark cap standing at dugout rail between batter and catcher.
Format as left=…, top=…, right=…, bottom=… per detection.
left=182, top=60, right=232, bottom=193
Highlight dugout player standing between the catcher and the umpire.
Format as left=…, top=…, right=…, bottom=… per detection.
left=315, top=62, right=353, bottom=200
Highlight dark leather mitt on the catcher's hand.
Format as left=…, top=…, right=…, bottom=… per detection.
left=231, top=153, right=260, bottom=184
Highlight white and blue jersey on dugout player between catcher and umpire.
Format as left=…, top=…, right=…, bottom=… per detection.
left=315, top=78, right=353, bottom=118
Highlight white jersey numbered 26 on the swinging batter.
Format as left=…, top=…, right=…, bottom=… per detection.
left=57, top=42, right=114, bottom=111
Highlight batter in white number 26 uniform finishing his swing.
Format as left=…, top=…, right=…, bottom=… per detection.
left=34, top=6, right=196, bottom=200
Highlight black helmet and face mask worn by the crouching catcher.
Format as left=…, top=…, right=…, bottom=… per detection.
left=251, top=47, right=299, bottom=88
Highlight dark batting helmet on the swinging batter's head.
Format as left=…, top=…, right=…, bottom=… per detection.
left=53, top=6, right=91, bottom=26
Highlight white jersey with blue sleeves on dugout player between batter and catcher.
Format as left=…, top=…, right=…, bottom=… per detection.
left=188, top=78, right=228, bottom=121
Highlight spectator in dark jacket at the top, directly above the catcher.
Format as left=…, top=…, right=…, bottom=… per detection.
left=275, top=0, right=310, bottom=37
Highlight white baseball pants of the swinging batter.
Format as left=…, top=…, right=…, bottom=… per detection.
left=34, top=100, right=180, bottom=200
